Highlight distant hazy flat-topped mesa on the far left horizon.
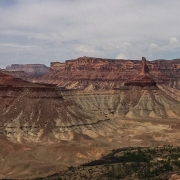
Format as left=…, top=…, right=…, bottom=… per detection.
left=6, top=64, right=49, bottom=77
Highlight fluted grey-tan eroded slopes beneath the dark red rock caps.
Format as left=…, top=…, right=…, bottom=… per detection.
left=0, top=87, right=180, bottom=142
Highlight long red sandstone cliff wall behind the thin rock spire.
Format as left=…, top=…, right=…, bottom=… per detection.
left=33, top=57, right=180, bottom=90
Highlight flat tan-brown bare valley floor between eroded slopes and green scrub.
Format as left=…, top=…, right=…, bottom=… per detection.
left=0, top=118, right=180, bottom=179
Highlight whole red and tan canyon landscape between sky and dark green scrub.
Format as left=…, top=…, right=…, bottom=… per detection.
left=0, top=57, right=180, bottom=178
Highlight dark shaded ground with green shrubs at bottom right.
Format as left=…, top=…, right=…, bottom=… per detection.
left=32, top=146, right=180, bottom=180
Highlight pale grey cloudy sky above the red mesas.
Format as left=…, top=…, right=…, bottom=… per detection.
left=0, top=0, right=180, bottom=68
